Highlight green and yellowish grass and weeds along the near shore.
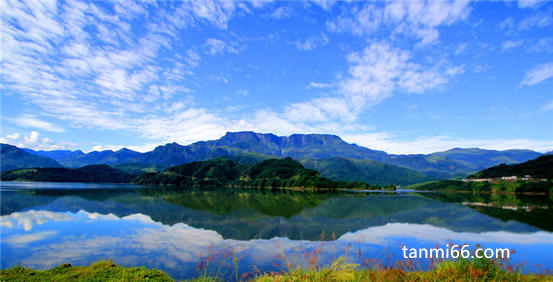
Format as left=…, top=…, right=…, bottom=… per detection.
left=0, top=257, right=553, bottom=282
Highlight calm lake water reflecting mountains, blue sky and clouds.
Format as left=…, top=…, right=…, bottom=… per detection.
left=0, top=182, right=553, bottom=279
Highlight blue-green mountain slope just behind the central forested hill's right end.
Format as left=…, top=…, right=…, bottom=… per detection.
left=301, top=158, right=436, bottom=185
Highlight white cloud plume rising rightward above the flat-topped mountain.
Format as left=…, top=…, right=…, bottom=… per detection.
left=194, top=43, right=465, bottom=141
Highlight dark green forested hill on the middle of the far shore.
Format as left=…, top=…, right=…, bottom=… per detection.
left=135, top=158, right=386, bottom=189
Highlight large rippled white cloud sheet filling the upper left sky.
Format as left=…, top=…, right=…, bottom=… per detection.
left=0, top=1, right=266, bottom=141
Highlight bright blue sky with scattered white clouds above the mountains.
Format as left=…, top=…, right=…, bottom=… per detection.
left=0, top=0, right=553, bottom=154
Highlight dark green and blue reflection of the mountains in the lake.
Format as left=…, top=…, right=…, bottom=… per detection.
left=1, top=182, right=553, bottom=240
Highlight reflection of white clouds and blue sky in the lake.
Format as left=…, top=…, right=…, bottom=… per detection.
left=2, top=210, right=553, bottom=279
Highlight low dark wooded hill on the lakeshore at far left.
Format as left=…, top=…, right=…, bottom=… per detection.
left=1, top=165, right=136, bottom=183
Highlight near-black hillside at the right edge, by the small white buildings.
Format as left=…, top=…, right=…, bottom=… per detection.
left=469, top=155, right=553, bottom=180
